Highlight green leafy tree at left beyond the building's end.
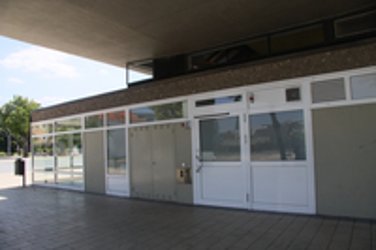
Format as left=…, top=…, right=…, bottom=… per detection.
left=0, top=96, right=40, bottom=155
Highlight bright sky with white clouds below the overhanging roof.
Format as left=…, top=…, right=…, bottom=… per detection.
left=0, top=36, right=127, bottom=107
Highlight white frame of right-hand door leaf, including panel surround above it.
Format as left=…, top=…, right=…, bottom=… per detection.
left=247, top=79, right=316, bottom=214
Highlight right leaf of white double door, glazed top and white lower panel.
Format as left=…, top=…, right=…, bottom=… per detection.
left=249, top=108, right=314, bottom=213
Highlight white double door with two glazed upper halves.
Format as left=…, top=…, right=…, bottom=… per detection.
left=194, top=109, right=315, bottom=213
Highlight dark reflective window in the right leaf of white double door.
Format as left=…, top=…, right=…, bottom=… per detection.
left=250, top=110, right=306, bottom=161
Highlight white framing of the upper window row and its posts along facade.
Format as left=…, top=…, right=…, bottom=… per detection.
left=31, top=66, right=376, bottom=212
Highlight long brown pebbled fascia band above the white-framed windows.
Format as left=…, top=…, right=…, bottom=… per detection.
left=32, top=39, right=376, bottom=122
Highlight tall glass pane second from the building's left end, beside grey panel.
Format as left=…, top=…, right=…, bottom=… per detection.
left=55, top=133, right=83, bottom=186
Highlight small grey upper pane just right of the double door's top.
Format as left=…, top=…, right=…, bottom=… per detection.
left=311, top=78, right=346, bottom=103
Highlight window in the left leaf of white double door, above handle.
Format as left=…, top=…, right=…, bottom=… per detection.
left=200, top=117, right=240, bottom=161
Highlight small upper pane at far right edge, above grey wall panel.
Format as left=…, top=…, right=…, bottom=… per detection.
left=350, top=74, right=376, bottom=99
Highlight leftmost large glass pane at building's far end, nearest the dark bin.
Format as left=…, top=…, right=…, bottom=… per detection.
left=32, top=136, right=54, bottom=172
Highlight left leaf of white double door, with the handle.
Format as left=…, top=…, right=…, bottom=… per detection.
left=194, top=113, right=248, bottom=208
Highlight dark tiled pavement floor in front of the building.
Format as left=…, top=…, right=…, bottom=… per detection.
left=0, top=187, right=376, bottom=250
